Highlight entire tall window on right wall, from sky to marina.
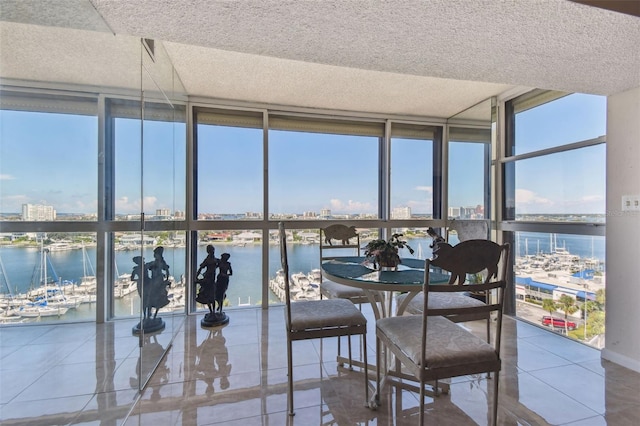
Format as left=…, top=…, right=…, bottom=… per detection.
left=503, top=91, right=606, bottom=347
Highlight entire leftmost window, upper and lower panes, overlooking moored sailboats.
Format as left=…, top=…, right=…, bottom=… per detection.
left=0, top=91, right=98, bottom=322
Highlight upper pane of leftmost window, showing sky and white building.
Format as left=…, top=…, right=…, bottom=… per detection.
left=0, top=110, right=98, bottom=221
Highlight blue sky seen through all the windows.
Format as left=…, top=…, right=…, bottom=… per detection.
left=0, top=95, right=606, bottom=214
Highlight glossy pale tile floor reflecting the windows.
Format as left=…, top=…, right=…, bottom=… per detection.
left=0, top=307, right=640, bottom=426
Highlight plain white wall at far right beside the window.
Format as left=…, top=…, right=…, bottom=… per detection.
left=602, top=87, right=640, bottom=372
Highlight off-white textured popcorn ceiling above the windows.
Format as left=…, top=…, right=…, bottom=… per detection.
left=0, top=0, right=640, bottom=117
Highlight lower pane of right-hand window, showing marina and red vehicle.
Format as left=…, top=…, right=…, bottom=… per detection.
left=514, top=232, right=606, bottom=348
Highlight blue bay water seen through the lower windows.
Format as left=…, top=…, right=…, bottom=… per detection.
left=0, top=232, right=605, bottom=319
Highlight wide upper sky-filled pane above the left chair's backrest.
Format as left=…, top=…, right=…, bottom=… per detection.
left=269, top=130, right=379, bottom=219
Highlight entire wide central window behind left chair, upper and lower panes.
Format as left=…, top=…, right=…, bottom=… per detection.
left=268, top=114, right=384, bottom=300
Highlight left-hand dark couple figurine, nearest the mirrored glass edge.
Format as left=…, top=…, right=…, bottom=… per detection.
left=131, top=246, right=171, bottom=334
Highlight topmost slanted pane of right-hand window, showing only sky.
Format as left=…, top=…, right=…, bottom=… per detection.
left=515, top=93, right=607, bottom=154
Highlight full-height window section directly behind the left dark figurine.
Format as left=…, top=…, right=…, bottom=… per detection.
left=108, top=99, right=187, bottom=317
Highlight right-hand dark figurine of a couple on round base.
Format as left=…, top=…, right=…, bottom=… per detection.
left=195, top=245, right=233, bottom=327
